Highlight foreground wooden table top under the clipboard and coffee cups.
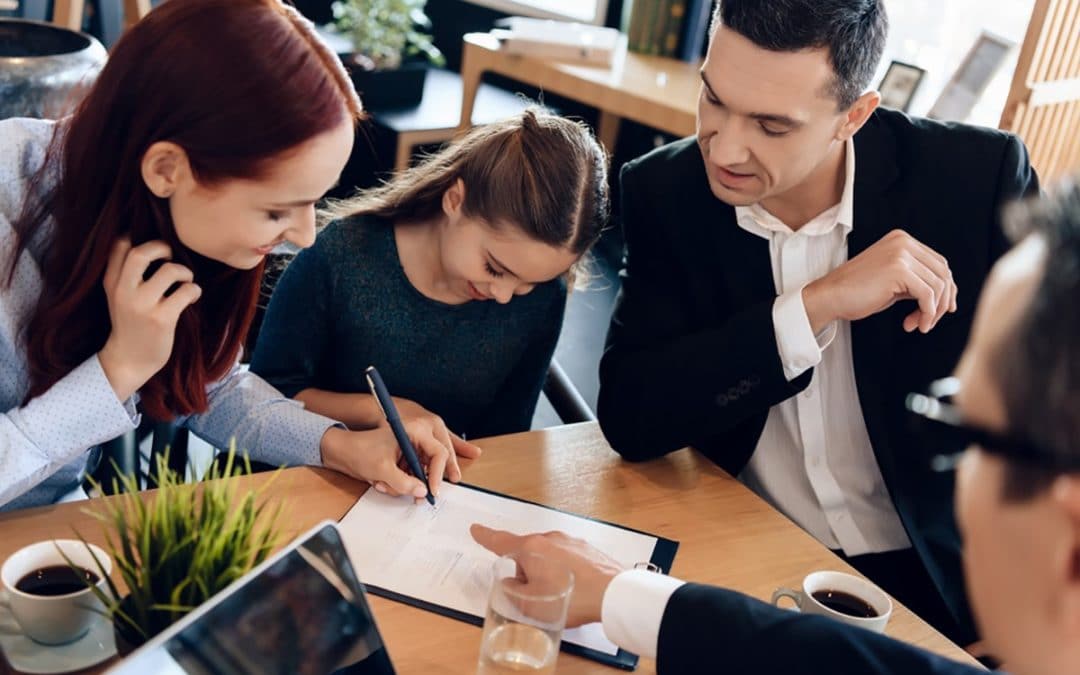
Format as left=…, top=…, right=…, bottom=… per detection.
left=0, top=422, right=976, bottom=675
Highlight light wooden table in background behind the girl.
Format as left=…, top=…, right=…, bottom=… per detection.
left=460, top=32, right=701, bottom=153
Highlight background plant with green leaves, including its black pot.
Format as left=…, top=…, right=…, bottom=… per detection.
left=330, top=0, right=445, bottom=108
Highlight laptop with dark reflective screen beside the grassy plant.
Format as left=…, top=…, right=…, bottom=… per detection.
left=108, top=521, right=394, bottom=675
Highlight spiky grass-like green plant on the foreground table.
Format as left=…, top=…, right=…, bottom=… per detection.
left=69, top=444, right=282, bottom=644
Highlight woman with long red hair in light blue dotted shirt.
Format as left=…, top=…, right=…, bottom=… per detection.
left=0, top=0, right=473, bottom=509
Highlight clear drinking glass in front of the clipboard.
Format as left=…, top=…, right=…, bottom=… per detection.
left=476, top=553, right=573, bottom=675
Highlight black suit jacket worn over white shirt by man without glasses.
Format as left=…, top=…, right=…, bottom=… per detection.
left=597, top=110, right=1038, bottom=636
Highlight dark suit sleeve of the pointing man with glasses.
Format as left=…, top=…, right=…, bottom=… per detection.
left=657, top=584, right=987, bottom=675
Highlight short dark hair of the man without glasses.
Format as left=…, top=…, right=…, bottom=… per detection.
left=710, top=0, right=889, bottom=110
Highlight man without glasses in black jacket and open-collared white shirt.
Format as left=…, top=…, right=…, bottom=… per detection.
left=598, top=0, right=1038, bottom=644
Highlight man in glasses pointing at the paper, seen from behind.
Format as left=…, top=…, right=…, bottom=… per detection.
left=473, top=185, right=1080, bottom=675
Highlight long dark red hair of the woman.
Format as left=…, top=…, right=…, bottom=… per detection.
left=9, top=0, right=361, bottom=419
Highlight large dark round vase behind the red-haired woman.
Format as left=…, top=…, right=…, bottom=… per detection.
left=0, top=18, right=107, bottom=120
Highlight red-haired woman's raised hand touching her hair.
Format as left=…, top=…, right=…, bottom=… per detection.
left=98, top=239, right=202, bottom=401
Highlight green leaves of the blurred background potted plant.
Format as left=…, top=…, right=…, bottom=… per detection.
left=333, top=0, right=445, bottom=68
